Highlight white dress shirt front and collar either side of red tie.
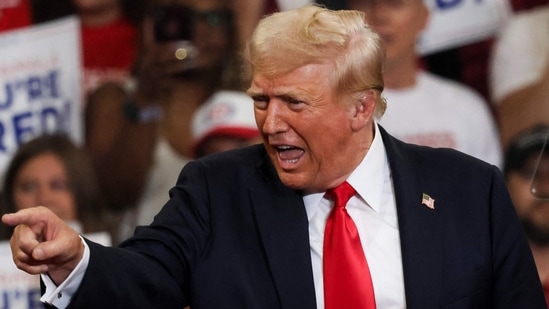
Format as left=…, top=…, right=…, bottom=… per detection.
left=303, top=125, right=406, bottom=309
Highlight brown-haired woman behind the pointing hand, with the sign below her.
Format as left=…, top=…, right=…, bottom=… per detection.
left=0, top=133, right=114, bottom=309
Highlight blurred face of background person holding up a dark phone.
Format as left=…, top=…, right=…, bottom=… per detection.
left=142, top=0, right=234, bottom=76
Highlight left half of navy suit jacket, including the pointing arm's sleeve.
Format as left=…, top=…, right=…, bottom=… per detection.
left=60, top=146, right=316, bottom=309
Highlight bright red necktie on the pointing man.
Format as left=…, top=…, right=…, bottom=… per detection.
left=323, top=182, right=376, bottom=309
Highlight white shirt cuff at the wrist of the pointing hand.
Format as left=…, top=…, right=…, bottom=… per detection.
left=40, top=236, right=90, bottom=309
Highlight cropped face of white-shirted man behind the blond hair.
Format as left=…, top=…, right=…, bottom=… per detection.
left=348, top=0, right=429, bottom=65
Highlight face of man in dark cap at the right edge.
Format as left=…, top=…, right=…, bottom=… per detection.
left=507, top=153, right=549, bottom=245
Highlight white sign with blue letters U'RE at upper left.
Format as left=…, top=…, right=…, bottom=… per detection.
left=0, top=17, right=82, bottom=183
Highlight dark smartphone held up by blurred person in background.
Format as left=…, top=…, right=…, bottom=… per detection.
left=153, top=5, right=193, bottom=42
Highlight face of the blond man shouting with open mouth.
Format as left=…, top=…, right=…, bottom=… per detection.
left=248, top=64, right=364, bottom=192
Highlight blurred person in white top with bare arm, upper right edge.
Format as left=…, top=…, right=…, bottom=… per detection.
left=489, top=5, right=549, bottom=148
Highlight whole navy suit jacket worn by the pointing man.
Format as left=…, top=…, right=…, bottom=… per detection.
left=63, top=129, right=546, bottom=309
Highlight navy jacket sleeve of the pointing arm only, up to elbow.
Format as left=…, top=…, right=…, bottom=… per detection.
left=62, top=159, right=210, bottom=309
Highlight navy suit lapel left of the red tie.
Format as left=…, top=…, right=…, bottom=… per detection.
left=250, top=153, right=316, bottom=308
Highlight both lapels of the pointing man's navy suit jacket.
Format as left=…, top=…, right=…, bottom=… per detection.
left=246, top=127, right=443, bottom=309
